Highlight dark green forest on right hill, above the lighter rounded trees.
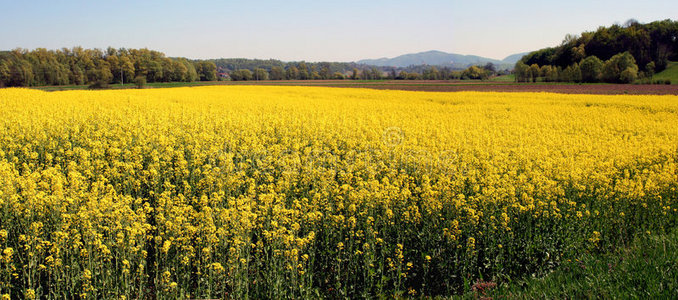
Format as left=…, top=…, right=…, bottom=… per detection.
left=521, top=20, right=678, bottom=72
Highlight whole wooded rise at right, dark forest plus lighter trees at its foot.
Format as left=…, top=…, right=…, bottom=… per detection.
left=514, top=20, right=678, bottom=83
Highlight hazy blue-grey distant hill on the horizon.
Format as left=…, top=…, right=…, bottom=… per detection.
left=357, top=50, right=524, bottom=68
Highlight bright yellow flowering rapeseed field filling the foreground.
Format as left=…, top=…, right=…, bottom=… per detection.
left=0, top=86, right=678, bottom=299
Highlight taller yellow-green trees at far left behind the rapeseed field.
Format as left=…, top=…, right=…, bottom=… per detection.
left=0, top=47, right=217, bottom=86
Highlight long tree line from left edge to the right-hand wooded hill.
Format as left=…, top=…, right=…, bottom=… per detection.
left=0, top=47, right=507, bottom=87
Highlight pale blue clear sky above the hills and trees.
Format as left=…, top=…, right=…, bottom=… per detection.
left=0, top=0, right=678, bottom=61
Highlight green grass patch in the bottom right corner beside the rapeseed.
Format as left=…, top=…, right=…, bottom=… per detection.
left=466, top=230, right=678, bottom=299
